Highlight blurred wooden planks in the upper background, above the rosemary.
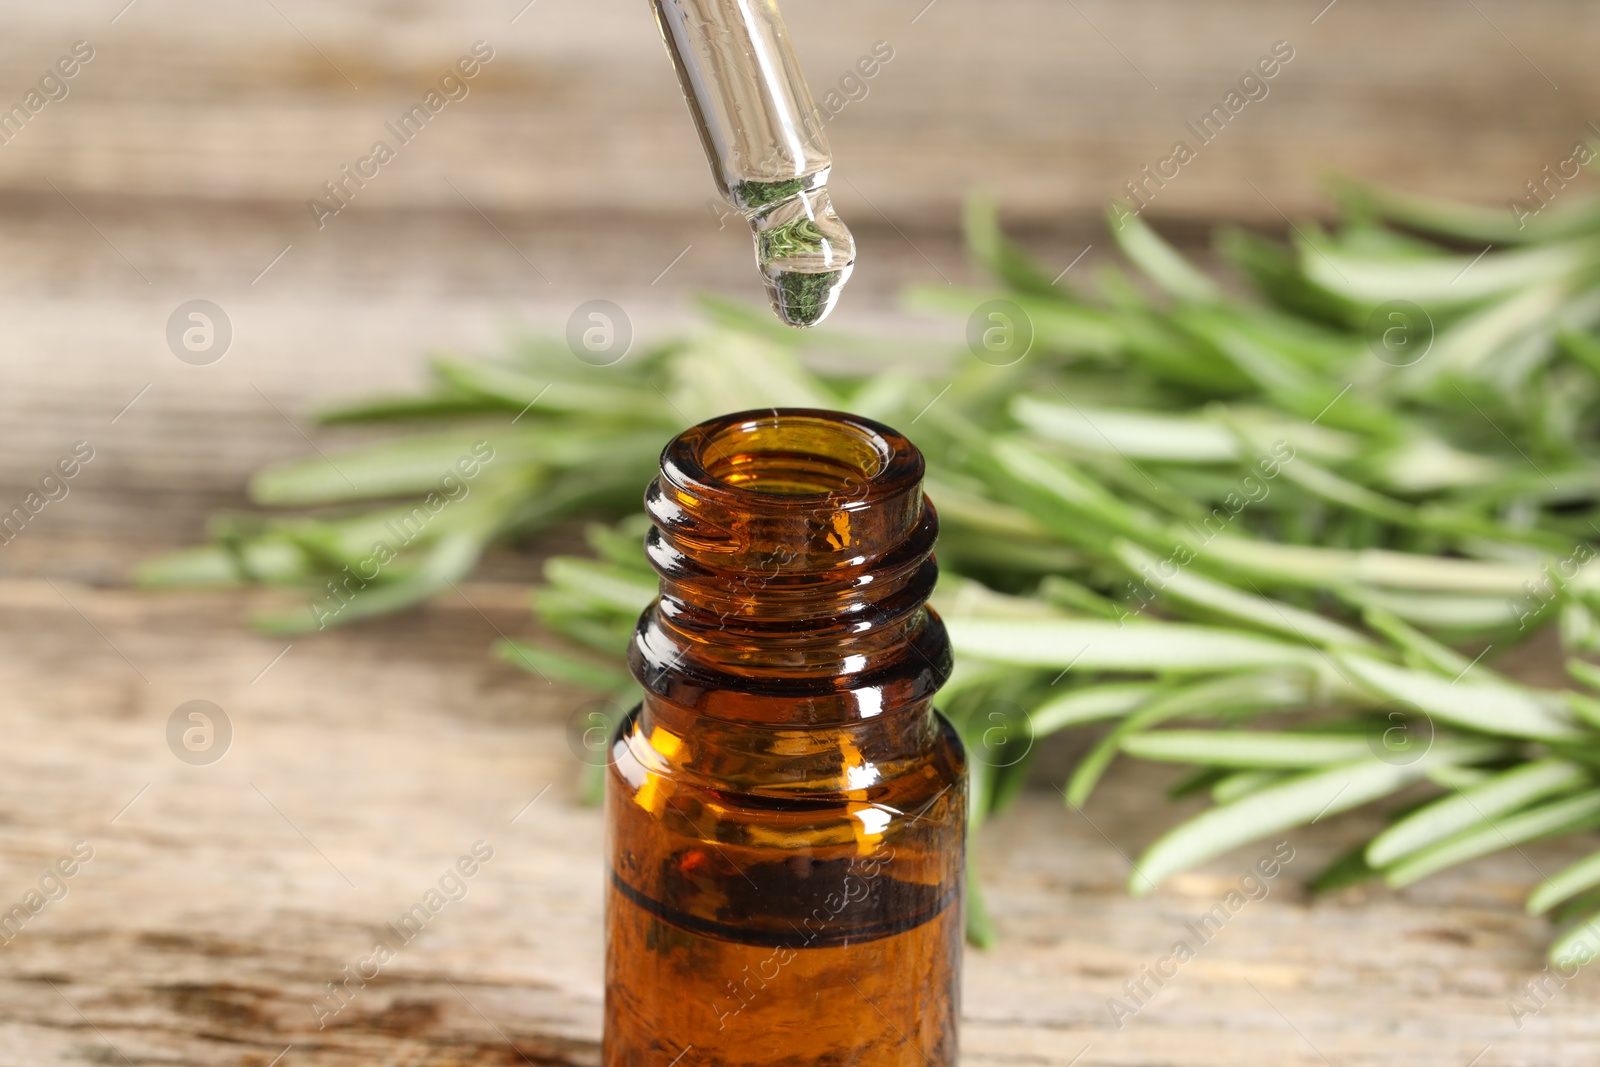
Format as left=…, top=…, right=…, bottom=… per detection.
left=0, top=0, right=1600, bottom=581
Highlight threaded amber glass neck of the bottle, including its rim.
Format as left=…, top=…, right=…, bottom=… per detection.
left=630, top=408, right=950, bottom=736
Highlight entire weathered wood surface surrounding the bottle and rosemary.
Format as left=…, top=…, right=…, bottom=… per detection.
left=0, top=0, right=1600, bottom=1067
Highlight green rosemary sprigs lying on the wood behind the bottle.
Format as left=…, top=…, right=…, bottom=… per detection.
left=141, top=184, right=1600, bottom=963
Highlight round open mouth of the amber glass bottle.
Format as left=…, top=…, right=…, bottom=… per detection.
left=698, top=411, right=894, bottom=498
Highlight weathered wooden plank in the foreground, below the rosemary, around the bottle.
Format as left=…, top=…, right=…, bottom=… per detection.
left=0, top=581, right=1600, bottom=1067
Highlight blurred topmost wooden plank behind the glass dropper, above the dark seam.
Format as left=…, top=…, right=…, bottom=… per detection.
left=0, top=0, right=1600, bottom=229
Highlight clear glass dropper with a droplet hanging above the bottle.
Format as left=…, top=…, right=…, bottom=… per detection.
left=653, top=0, right=856, bottom=328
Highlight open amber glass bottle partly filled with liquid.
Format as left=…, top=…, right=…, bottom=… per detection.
left=605, top=408, right=966, bottom=1067
